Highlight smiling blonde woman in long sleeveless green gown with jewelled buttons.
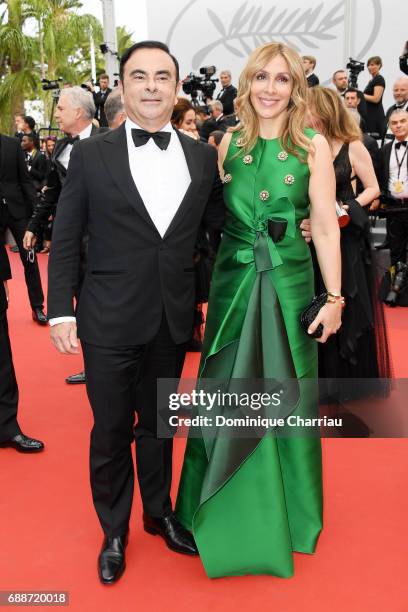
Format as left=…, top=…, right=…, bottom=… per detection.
left=176, top=43, right=341, bottom=577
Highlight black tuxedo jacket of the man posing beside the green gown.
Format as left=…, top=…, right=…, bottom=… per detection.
left=48, top=124, right=224, bottom=347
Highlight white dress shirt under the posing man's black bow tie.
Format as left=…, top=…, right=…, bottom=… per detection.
left=49, top=119, right=191, bottom=327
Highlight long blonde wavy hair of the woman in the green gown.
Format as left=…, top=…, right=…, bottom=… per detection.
left=234, top=42, right=313, bottom=161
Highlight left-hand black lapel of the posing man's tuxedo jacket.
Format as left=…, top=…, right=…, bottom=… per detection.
left=101, top=123, right=160, bottom=235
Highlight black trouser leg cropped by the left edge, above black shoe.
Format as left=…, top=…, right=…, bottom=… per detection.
left=0, top=314, right=21, bottom=442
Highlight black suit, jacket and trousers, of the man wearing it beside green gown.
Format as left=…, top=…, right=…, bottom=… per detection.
left=48, top=125, right=224, bottom=535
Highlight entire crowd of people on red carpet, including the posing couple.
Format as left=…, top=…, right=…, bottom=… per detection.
left=0, top=41, right=408, bottom=583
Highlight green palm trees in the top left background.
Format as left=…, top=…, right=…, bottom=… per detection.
left=0, top=0, right=133, bottom=133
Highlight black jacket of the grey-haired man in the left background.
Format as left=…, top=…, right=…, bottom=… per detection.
left=27, top=125, right=98, bottom=234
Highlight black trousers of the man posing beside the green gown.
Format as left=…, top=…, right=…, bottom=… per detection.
left=82, top=318, right=186, bottom=536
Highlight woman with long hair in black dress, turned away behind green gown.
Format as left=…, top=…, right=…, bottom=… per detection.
left=308, top=87, right=390, bottom=400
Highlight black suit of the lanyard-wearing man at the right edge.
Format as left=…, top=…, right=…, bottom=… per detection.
left=380, top=142, right=408, bottom=266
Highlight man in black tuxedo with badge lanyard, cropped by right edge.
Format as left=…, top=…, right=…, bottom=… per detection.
left=380, top=109, right=408, bottom=266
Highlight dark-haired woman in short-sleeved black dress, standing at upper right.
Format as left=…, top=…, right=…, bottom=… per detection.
left=364, top=56, right=385, bottom=138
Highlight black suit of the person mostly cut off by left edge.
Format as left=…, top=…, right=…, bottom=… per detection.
left=0, top=237, right=21, bottom=443
